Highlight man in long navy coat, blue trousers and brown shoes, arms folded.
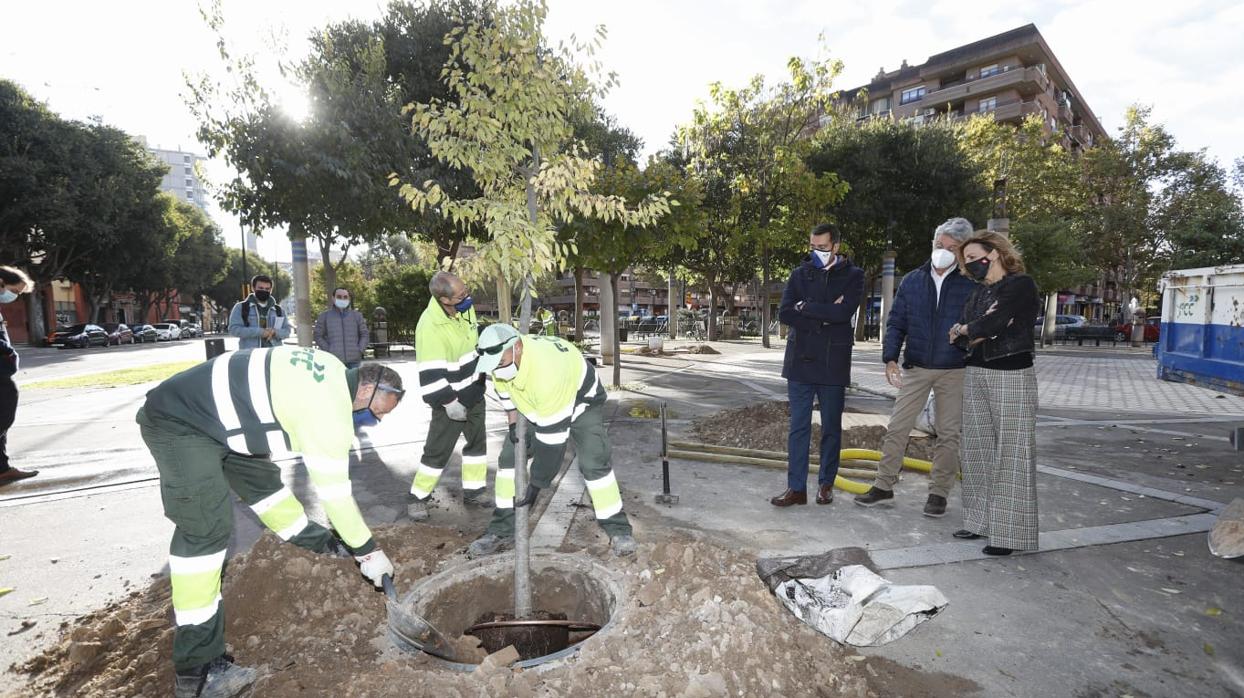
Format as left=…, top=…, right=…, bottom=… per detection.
left=769, top=224, right=863, bottom=506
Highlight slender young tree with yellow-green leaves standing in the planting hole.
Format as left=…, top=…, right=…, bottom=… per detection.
left=389, top=0, right=669, bottom=617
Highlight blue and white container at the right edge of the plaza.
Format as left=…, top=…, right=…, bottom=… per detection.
left=1157, top=264, right=1244, bottom=396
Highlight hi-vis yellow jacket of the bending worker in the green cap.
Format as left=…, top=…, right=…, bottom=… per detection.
left=493, top=335, right=608, bottom=482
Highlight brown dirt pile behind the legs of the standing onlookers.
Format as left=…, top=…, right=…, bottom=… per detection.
left=692, top=401, right=934, bottom=460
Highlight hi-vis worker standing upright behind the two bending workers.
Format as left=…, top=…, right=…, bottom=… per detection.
left=406, top=271, right=488, bottom=521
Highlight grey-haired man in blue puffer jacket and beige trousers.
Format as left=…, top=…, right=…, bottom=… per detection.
left=855, top=218, right=975, bottom=518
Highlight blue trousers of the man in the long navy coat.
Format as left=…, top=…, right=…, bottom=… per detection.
left=786, top=381, right=846, bottom=491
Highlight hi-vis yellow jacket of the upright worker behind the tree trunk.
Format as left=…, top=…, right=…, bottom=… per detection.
left=414, top=299, right=484, bottom=407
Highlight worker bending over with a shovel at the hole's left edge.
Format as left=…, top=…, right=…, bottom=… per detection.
left=137, top=347, right=404, bottom=698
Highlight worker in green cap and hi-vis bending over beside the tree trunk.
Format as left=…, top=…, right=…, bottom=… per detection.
left=467, top=325, right=636, bottom=557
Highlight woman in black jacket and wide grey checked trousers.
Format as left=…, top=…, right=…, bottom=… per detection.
left=949, top=231, right=1041, bottom=555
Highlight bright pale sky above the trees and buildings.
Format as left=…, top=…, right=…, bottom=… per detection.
left=0, top=0, right=1244, bottom=260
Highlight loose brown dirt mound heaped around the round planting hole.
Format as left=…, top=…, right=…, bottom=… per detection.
left=12, top=525, right=887, bottom=698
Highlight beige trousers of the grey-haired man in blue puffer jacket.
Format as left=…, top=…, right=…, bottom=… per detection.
left=872, top=366, right=963, bottom=496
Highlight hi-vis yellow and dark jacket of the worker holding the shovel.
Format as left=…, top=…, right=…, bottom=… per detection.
left=146, top=347, right=376, bottom=555
